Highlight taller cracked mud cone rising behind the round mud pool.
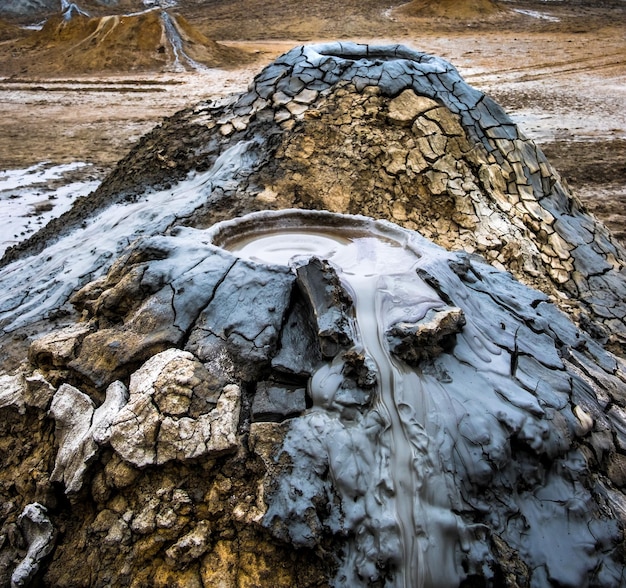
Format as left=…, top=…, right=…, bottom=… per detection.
left=3, top=44, right=626, bottom=350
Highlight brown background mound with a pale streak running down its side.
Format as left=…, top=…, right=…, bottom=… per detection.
left=5, top=10, right=248, bottom=75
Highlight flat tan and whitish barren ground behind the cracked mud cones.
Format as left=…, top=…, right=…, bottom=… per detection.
left=0, top=0, right=626, bottom=241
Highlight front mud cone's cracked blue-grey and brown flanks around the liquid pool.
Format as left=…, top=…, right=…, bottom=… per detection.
left=3, top=206, right=626, bottom=587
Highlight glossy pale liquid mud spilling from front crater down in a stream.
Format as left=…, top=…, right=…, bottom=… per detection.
left=227, top=219, right=459, bottom=588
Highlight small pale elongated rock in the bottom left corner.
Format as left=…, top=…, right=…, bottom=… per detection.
left=11, top=503, right=56, bottom=588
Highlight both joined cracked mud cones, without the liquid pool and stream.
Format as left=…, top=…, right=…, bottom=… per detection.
left=0, top=43, right=626, bottom=586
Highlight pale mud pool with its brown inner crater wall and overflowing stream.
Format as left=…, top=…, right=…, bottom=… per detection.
left=216, top=212, right=463, bottom=588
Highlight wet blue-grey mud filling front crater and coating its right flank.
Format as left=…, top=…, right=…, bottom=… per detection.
left=211, top=212, right=624, bottom=587
